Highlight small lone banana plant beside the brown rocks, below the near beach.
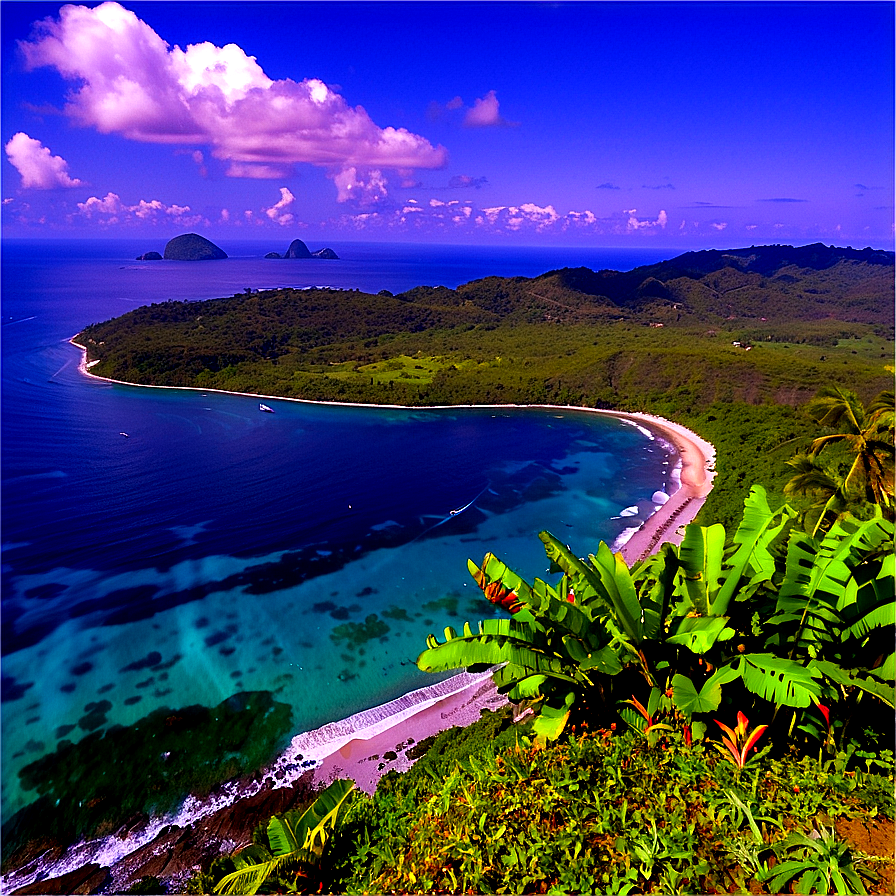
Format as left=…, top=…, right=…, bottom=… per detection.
left=215, top=780, right=355, bottom=894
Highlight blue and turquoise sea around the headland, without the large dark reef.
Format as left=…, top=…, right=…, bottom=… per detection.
left=0, top=239, right=676, bottom=813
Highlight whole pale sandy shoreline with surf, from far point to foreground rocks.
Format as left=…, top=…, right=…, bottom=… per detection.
left=10, top=337, right=715, bottom=892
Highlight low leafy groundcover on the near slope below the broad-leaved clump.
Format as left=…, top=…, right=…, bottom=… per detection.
left=188, top=708, right=894, bottom=894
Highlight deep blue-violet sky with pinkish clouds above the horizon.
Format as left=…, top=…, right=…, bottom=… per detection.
left=0, top=0, right=896, bottom=250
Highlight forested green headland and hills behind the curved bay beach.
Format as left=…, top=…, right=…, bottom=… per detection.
left=77, top=246, right=894, bottom=525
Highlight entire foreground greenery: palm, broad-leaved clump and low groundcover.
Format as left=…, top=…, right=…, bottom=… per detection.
left=178, top=390, right=896, bottom=894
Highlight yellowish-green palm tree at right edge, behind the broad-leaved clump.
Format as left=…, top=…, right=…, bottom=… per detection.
left=784, top=386, right=894, bottom=535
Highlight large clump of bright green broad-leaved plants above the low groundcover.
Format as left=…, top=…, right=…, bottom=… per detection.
left=418, top=486, right=896, bottom=742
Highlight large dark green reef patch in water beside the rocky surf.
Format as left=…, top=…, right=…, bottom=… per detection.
left=2, top=691, right=292, bottom=869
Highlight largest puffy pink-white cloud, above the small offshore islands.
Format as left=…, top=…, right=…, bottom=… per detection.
left=21, top=2, right=447, bottom=198
